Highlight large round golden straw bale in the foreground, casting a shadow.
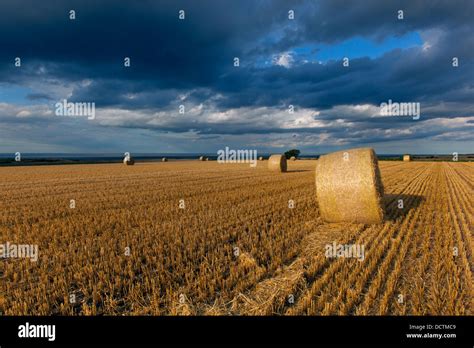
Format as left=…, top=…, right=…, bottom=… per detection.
left=316, top=148, right=384, bottom=224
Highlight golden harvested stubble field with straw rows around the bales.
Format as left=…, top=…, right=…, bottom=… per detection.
left=0, top=160, right=474, bottom=315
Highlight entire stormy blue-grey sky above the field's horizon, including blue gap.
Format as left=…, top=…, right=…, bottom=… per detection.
left=0, top=0, right=474, bottom=154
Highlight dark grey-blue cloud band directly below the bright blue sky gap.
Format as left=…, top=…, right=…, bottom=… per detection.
left=219, top=31, right=474, bottom=113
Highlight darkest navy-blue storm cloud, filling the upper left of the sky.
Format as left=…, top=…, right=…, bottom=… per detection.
left=0, top=0, right=296, bottom=88
